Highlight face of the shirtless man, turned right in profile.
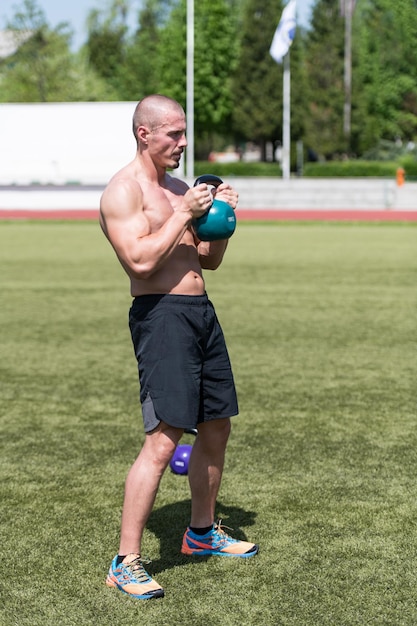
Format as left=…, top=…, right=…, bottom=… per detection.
left=148, top=113, right=187, bottom=169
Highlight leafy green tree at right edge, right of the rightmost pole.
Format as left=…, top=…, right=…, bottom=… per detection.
left=353, top=0, right=417, bottom=153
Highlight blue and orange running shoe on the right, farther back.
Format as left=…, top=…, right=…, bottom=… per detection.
left=181, top=520, right=259, bottom=559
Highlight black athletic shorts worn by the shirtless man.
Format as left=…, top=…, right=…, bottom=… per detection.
left=129, top=294, right=238, bottom=432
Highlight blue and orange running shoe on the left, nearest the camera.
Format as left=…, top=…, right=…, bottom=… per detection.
left=106, top=554, right=164, bottom=600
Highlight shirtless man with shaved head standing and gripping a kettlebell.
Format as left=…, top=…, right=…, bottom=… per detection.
left=100, top=95, right=258, bottom=599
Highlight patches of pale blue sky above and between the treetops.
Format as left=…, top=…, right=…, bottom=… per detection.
left=0, top=0, right=315, bottom=50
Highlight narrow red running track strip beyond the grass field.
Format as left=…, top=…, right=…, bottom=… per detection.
left=0, top=209, right=417, bottom=222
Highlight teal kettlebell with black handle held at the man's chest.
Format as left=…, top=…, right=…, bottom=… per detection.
left=193, top=174, right=236, bottom=241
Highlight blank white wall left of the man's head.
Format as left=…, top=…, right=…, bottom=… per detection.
left=0, top=102, right=140, bottom=185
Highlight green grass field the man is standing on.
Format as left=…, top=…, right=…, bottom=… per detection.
left=0, top=222, right=417, bottom=626
